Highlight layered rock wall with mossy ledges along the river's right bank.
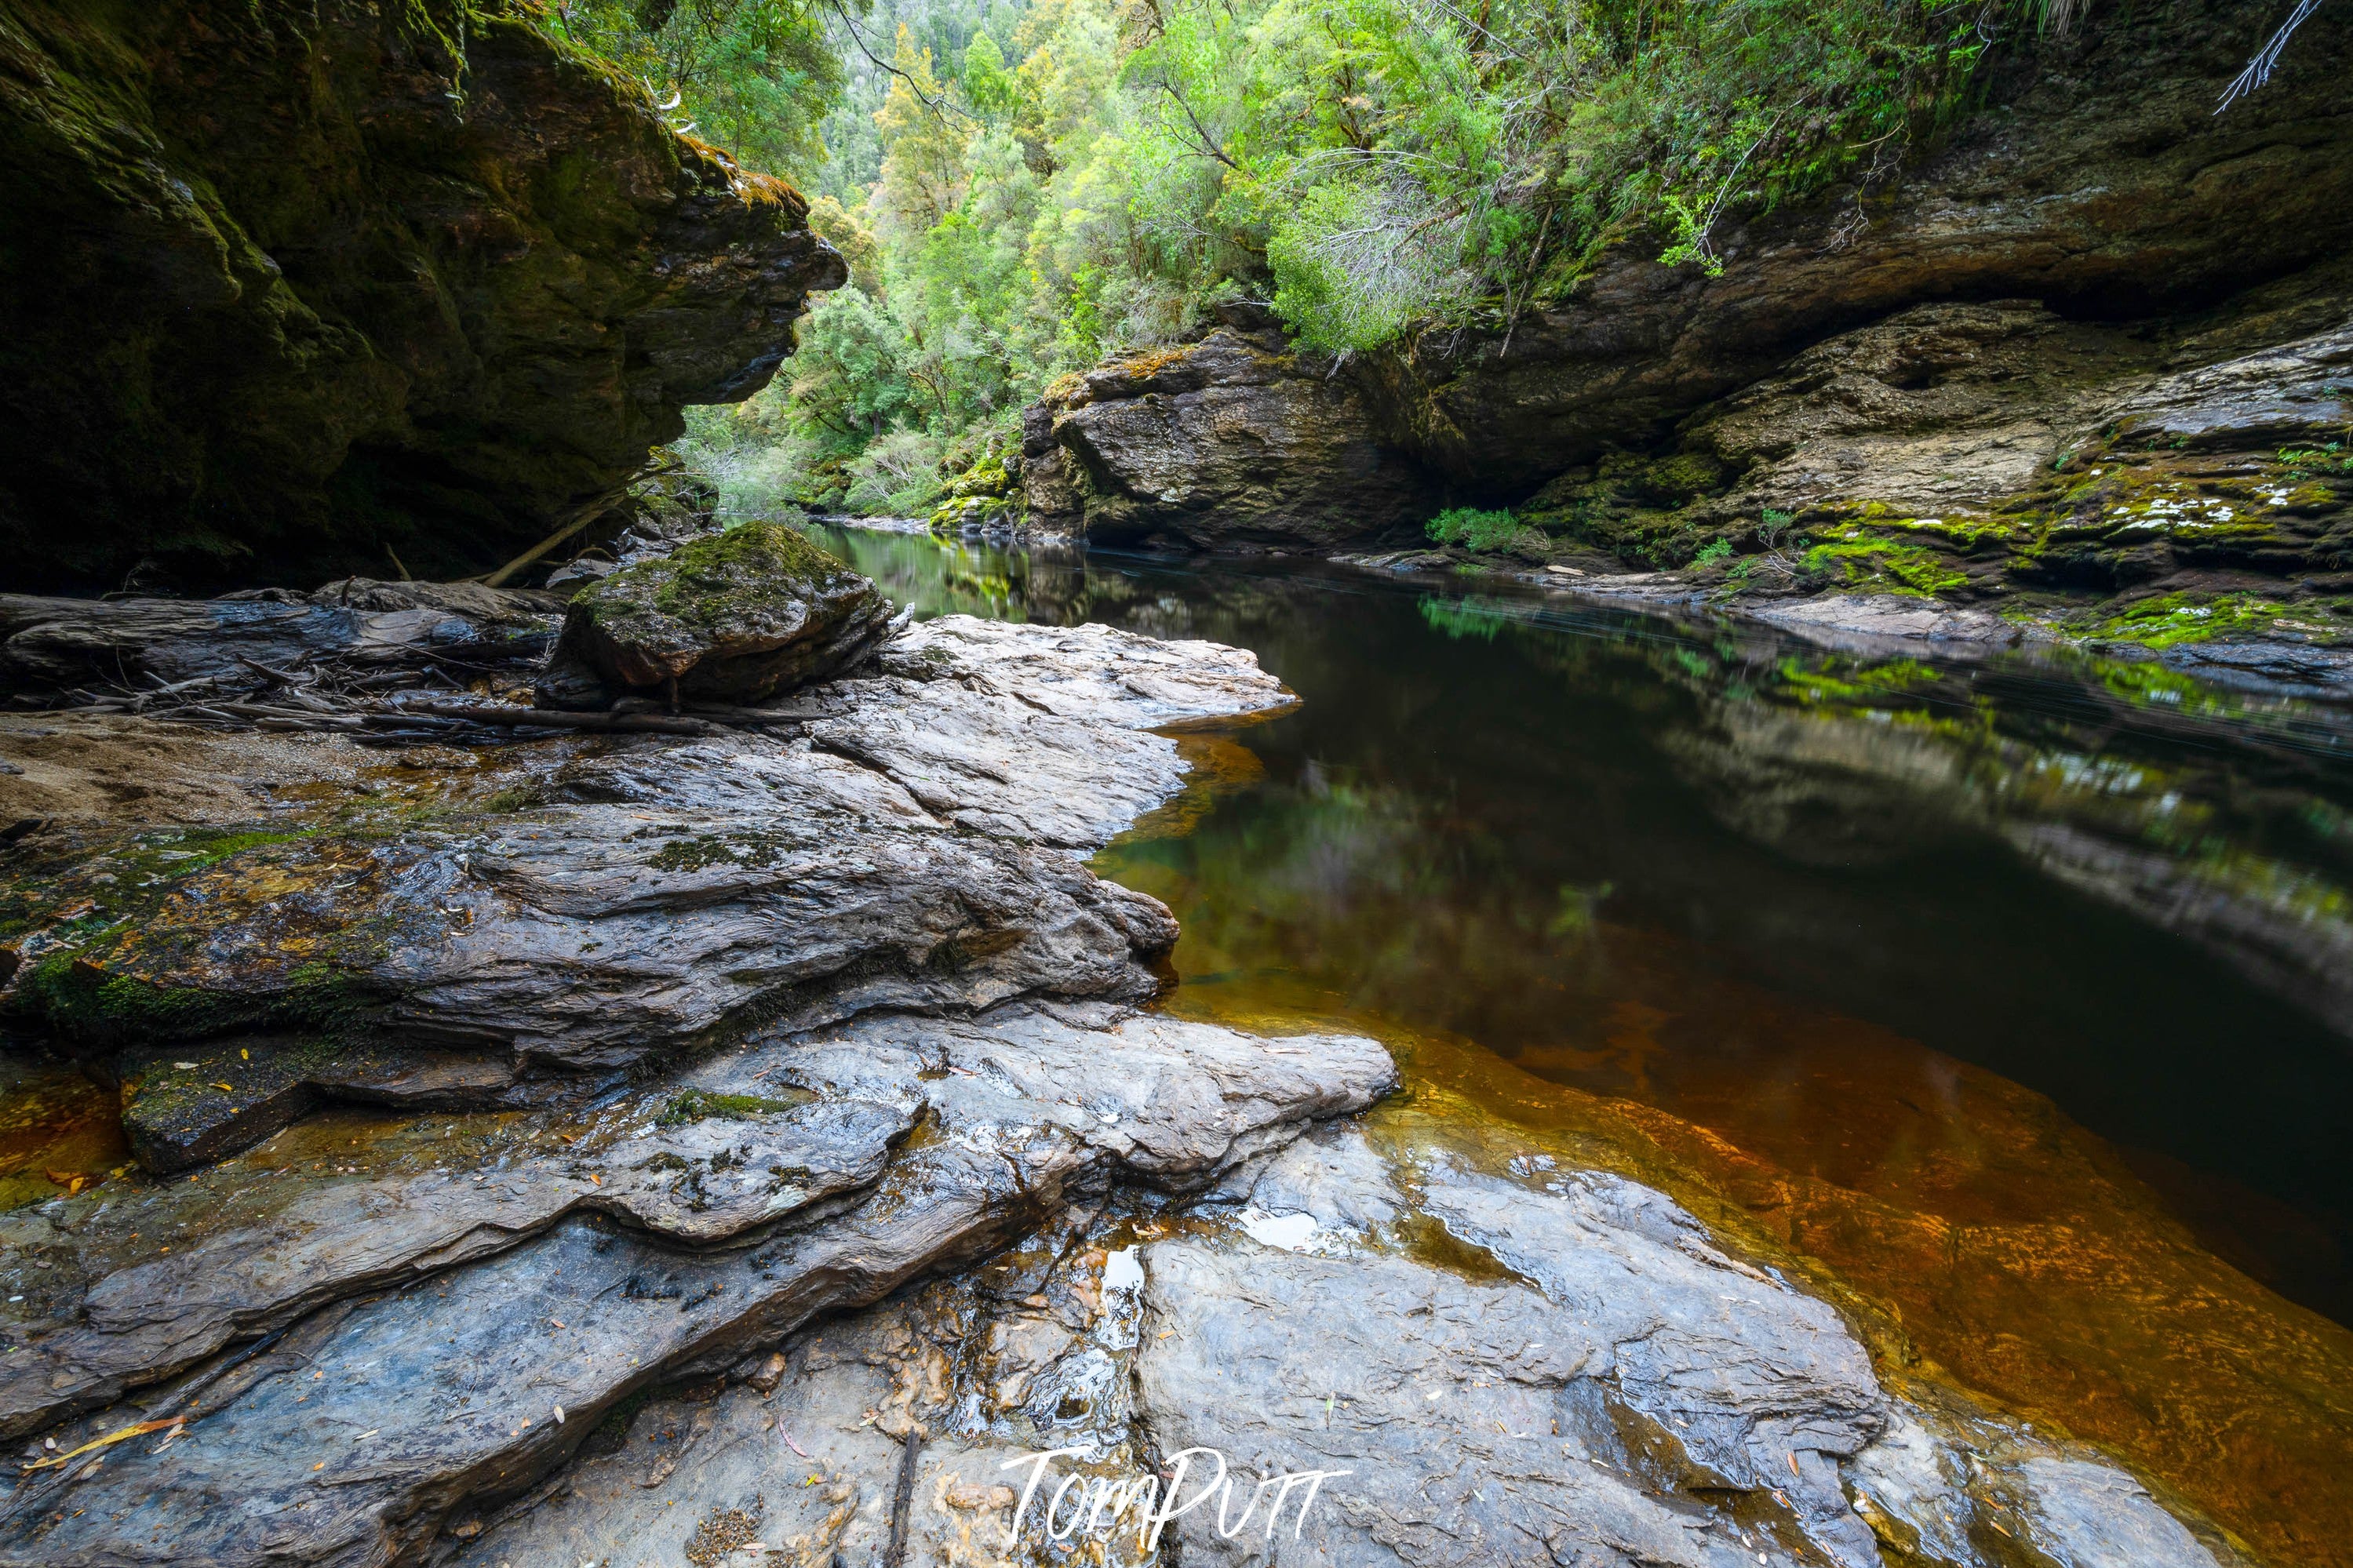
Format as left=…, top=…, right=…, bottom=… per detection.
left=1024, top=5, right=2353, bottom=696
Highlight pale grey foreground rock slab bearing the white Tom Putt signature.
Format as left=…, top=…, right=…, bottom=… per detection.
left=432, top=1112, right=2238, bottom=1568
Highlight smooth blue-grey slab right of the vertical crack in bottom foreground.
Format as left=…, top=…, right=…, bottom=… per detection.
left=1137, top=1117, right=2216, bottom=1568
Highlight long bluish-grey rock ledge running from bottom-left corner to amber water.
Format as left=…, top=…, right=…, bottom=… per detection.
left=9, top=1009, right=1393, bottom=1561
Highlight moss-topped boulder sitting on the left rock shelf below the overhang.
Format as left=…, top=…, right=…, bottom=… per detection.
left=544, top=522, right=892, bottom=703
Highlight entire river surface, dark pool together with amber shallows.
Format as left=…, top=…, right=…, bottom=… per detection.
left=821, top=529, right=2353, bottom=1561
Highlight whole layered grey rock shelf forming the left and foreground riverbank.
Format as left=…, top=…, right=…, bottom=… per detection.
left=0, top=562, right=2318, bottom=1566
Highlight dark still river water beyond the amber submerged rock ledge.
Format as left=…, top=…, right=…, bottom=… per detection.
left=821, top=529, right=2353, bottom=1321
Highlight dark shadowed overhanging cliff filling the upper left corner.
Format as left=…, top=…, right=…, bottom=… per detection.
left=0, top=0, right=845, bottom=588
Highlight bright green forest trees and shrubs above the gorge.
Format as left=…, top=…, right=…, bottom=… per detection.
left=548, top=0, right=2068, bottom=512
